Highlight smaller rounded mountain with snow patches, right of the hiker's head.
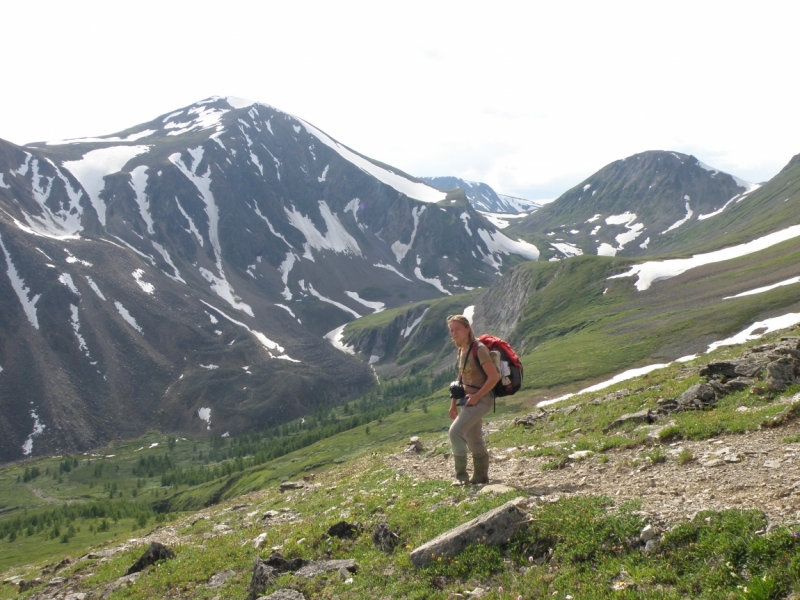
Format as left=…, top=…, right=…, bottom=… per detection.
left=509, top=151, right=758, bottom=258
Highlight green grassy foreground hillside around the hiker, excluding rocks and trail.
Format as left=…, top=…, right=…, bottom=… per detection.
left=0, top=335, right=800, bottom=599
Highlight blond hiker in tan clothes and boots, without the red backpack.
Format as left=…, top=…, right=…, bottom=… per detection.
left=447, top=315, right=500, bottom=484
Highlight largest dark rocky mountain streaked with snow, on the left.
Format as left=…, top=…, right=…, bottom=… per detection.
left=0, top=97, right=538, bottom=460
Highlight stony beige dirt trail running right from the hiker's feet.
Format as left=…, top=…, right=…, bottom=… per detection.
left=389, top=423, right=800, bottom=525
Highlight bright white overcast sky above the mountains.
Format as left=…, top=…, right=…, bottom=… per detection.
left=0, top=0, right=800, bottom=199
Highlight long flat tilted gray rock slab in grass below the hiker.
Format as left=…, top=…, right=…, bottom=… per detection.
left=411, top=498, right=528, bottom=569
